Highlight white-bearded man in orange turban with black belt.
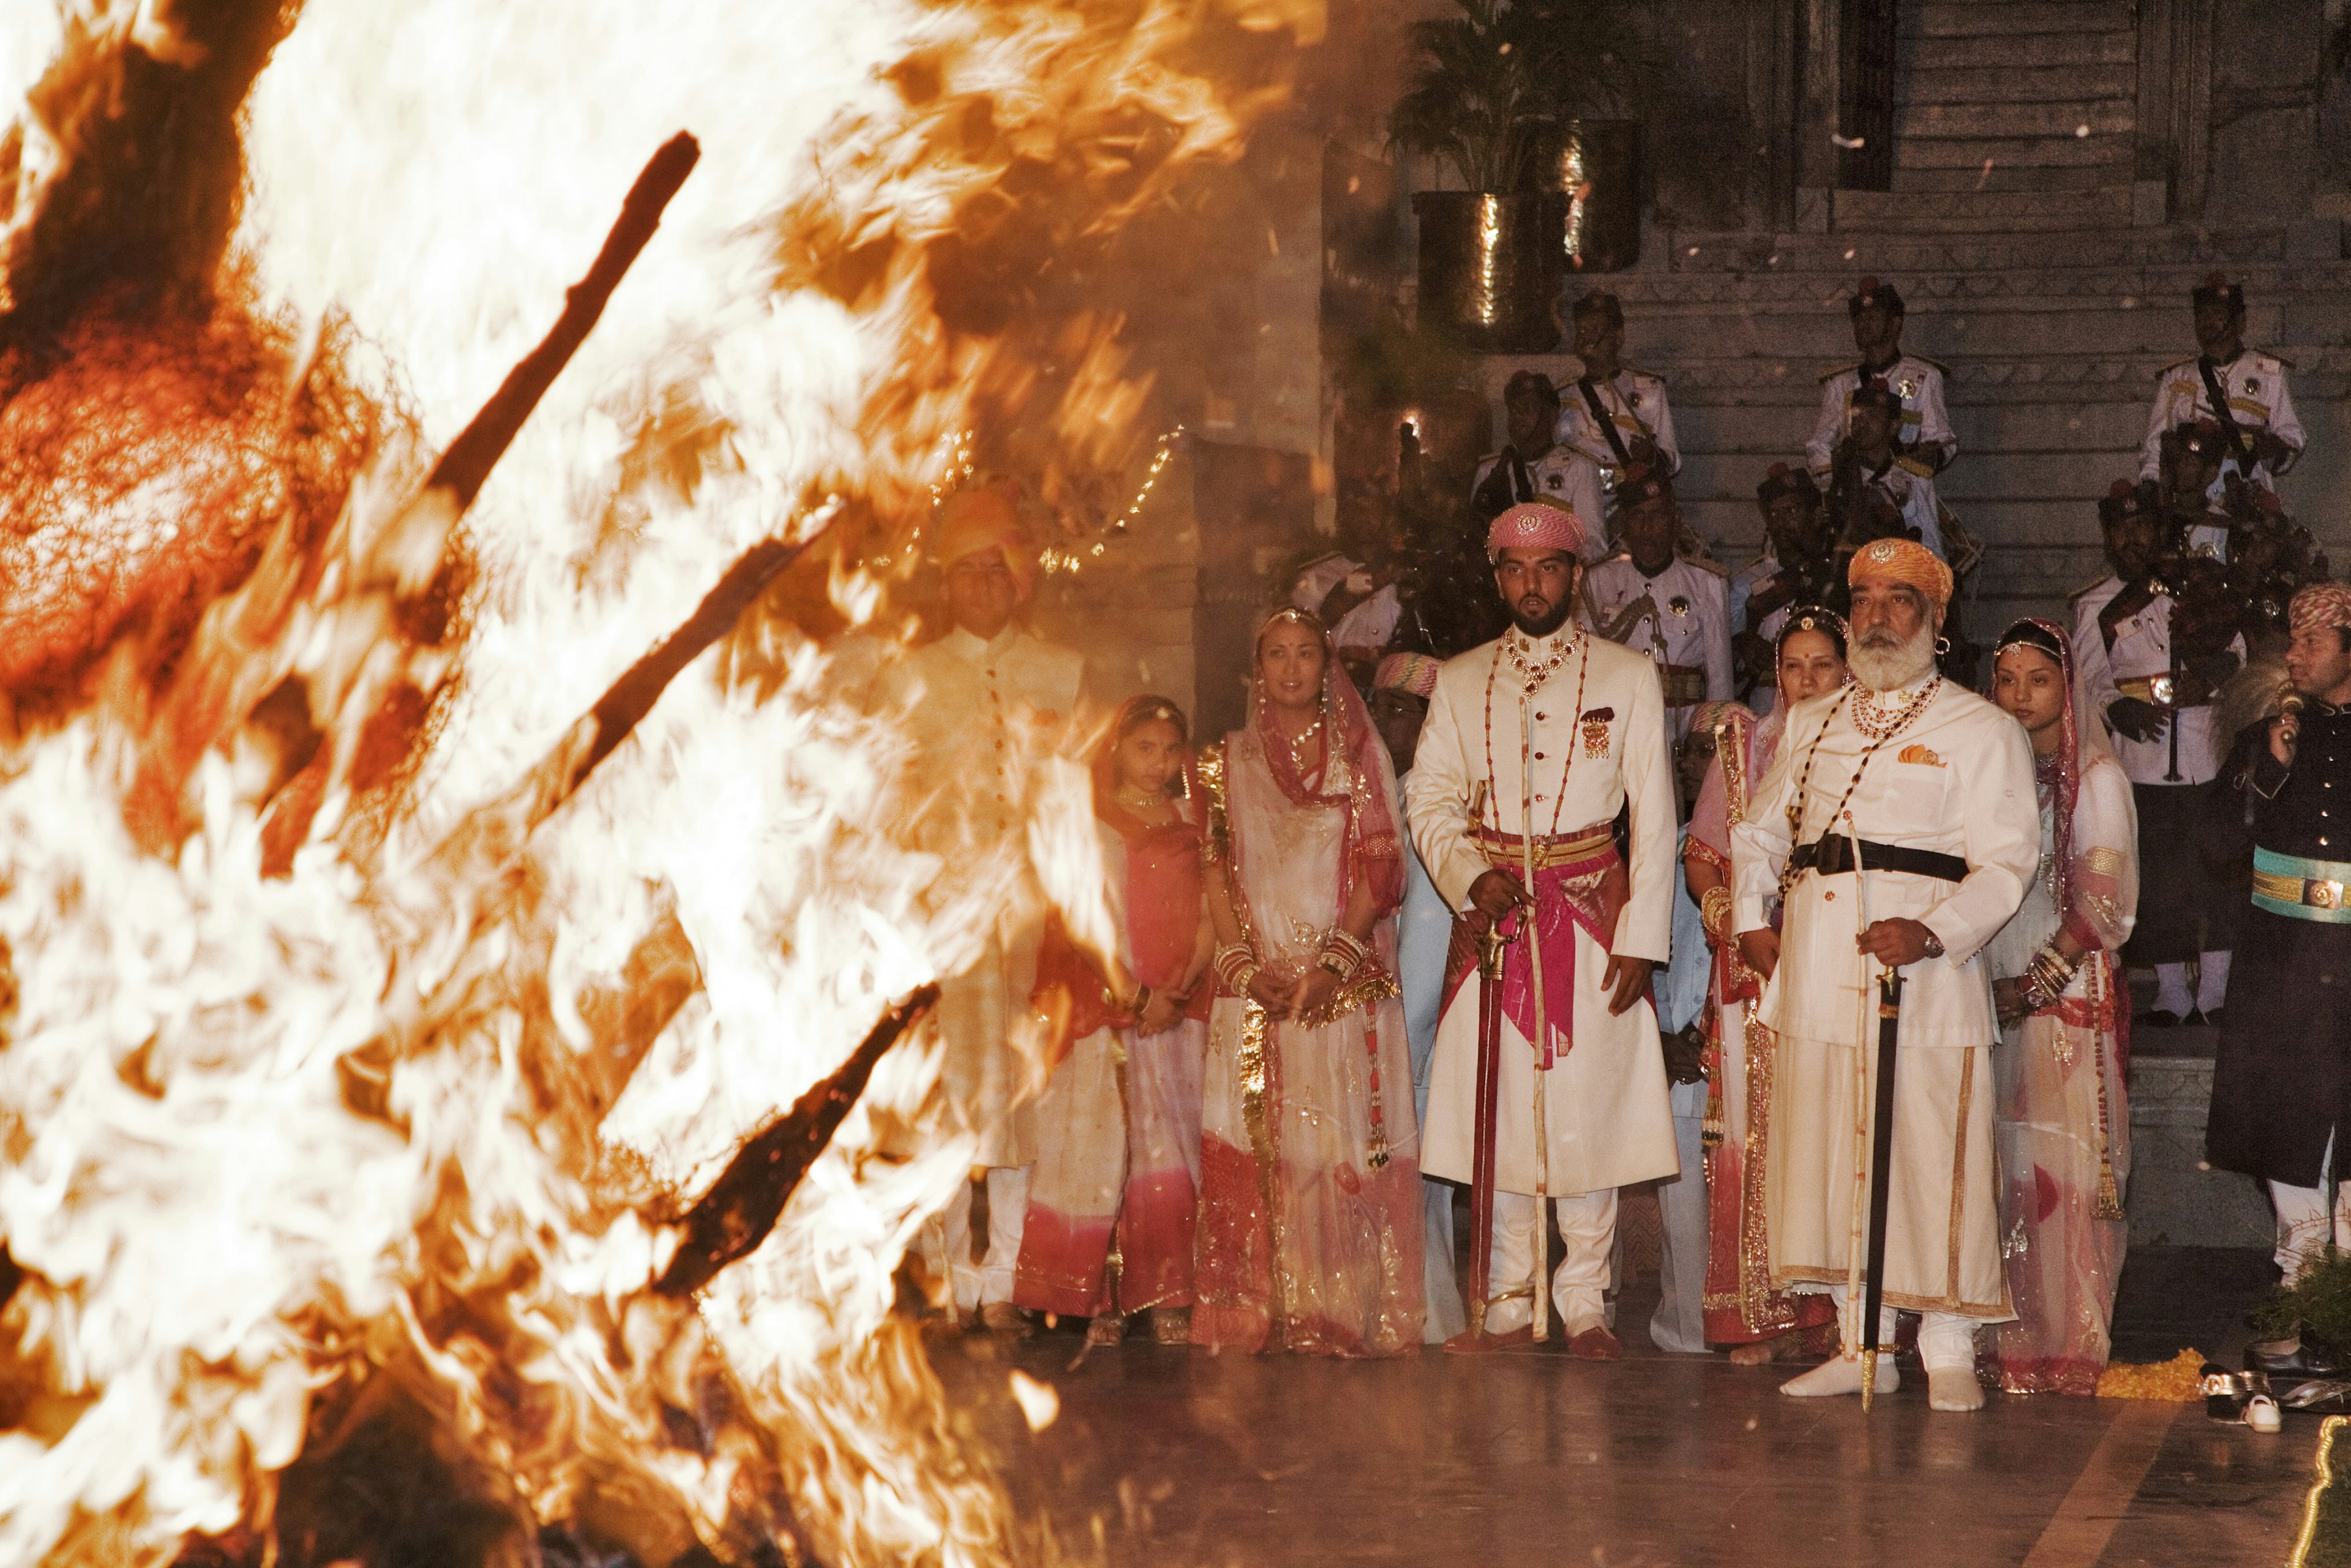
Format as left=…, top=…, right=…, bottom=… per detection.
left=1730, top=538, right=2041, bottom=1411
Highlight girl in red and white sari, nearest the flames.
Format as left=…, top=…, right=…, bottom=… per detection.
left=1013, top=696, right=1213, bottom=1345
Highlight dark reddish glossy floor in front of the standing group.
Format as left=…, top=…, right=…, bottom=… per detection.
left=936, top=1260, right=2320, bottom=1568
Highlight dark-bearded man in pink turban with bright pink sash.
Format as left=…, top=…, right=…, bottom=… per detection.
left=1406, top=501, right=1679, bottom=1359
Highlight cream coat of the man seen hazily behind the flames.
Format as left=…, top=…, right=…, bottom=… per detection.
left=874, top=628, right=1086, bottom=1166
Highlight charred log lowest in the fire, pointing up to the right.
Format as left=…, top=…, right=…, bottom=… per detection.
left=654, top=983, right=938, bottom=1296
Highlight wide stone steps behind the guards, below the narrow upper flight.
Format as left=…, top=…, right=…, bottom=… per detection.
left=1486, top=227, right=2351, bottom=637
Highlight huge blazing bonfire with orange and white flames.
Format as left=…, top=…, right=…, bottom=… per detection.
left=0, top=0, right=1316, bottom=1563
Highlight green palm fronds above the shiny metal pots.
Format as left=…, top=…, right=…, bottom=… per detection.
left=1387, top=0, right=1653, bottom=193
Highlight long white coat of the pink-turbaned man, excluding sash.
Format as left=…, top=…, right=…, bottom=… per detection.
left=1408, top=630, right=1679, bottom=1196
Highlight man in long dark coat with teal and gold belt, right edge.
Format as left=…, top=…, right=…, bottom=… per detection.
left=2210, top=583, right=2351, bottom=1279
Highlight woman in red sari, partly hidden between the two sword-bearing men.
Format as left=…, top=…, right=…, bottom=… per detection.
left=1681, top=607, right=1845, bottom=1366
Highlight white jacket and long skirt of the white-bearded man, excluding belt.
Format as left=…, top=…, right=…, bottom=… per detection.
left=1730, top=681, right=2041, bottom=1319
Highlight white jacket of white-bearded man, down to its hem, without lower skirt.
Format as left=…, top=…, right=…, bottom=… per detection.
left=1730, top=677, right=2041, bottom=1048
